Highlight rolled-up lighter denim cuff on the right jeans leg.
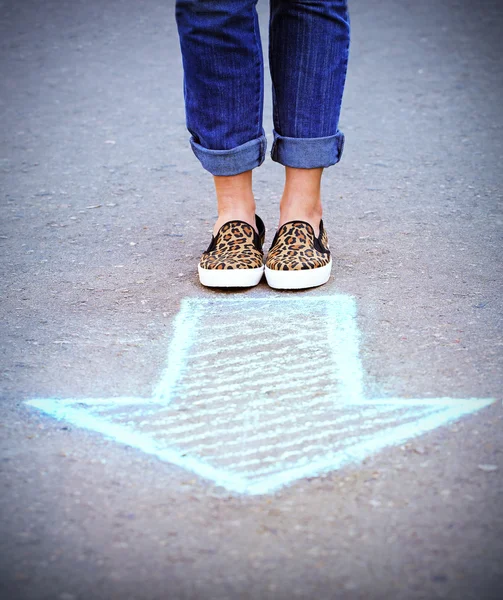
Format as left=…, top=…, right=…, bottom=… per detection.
left=271, top=131, right=344, bottom=169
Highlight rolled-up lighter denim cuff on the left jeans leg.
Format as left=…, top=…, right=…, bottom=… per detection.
left=190, top=133, right=267, bottom=175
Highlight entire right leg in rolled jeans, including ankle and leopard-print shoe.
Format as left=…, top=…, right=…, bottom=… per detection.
left=265, top=0, right=349, bottom=289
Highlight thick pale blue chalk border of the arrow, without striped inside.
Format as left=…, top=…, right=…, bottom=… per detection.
left=25, top=294, right=495, bottom=495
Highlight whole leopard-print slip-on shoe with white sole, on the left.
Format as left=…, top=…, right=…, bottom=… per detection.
left=198, top=215, right=265, bottom=287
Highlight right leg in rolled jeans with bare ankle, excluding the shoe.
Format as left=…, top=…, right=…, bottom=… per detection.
left=269, top=0, right=349, bottom=232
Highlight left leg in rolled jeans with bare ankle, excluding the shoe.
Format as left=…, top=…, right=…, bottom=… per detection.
left=176, top=0, right=266, bottom=233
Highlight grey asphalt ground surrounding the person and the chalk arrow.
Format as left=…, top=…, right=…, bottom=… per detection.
left=0, top=0, right=503, bottom=600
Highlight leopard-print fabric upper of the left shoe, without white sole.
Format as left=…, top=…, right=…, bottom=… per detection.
left=199, top=218, right=265, bottom=270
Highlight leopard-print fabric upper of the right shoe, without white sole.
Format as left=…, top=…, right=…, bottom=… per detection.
left=265, top=221, right=330, bottom=271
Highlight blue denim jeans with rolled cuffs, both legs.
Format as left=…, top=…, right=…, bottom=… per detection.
left=176, top=0, right=349, bottom=175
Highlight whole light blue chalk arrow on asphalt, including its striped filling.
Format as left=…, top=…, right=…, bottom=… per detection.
left=28, top=295, right=494, bottom=494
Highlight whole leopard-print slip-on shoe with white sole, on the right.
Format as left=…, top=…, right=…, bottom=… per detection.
left=265, top=221, right=332, bottom=290
